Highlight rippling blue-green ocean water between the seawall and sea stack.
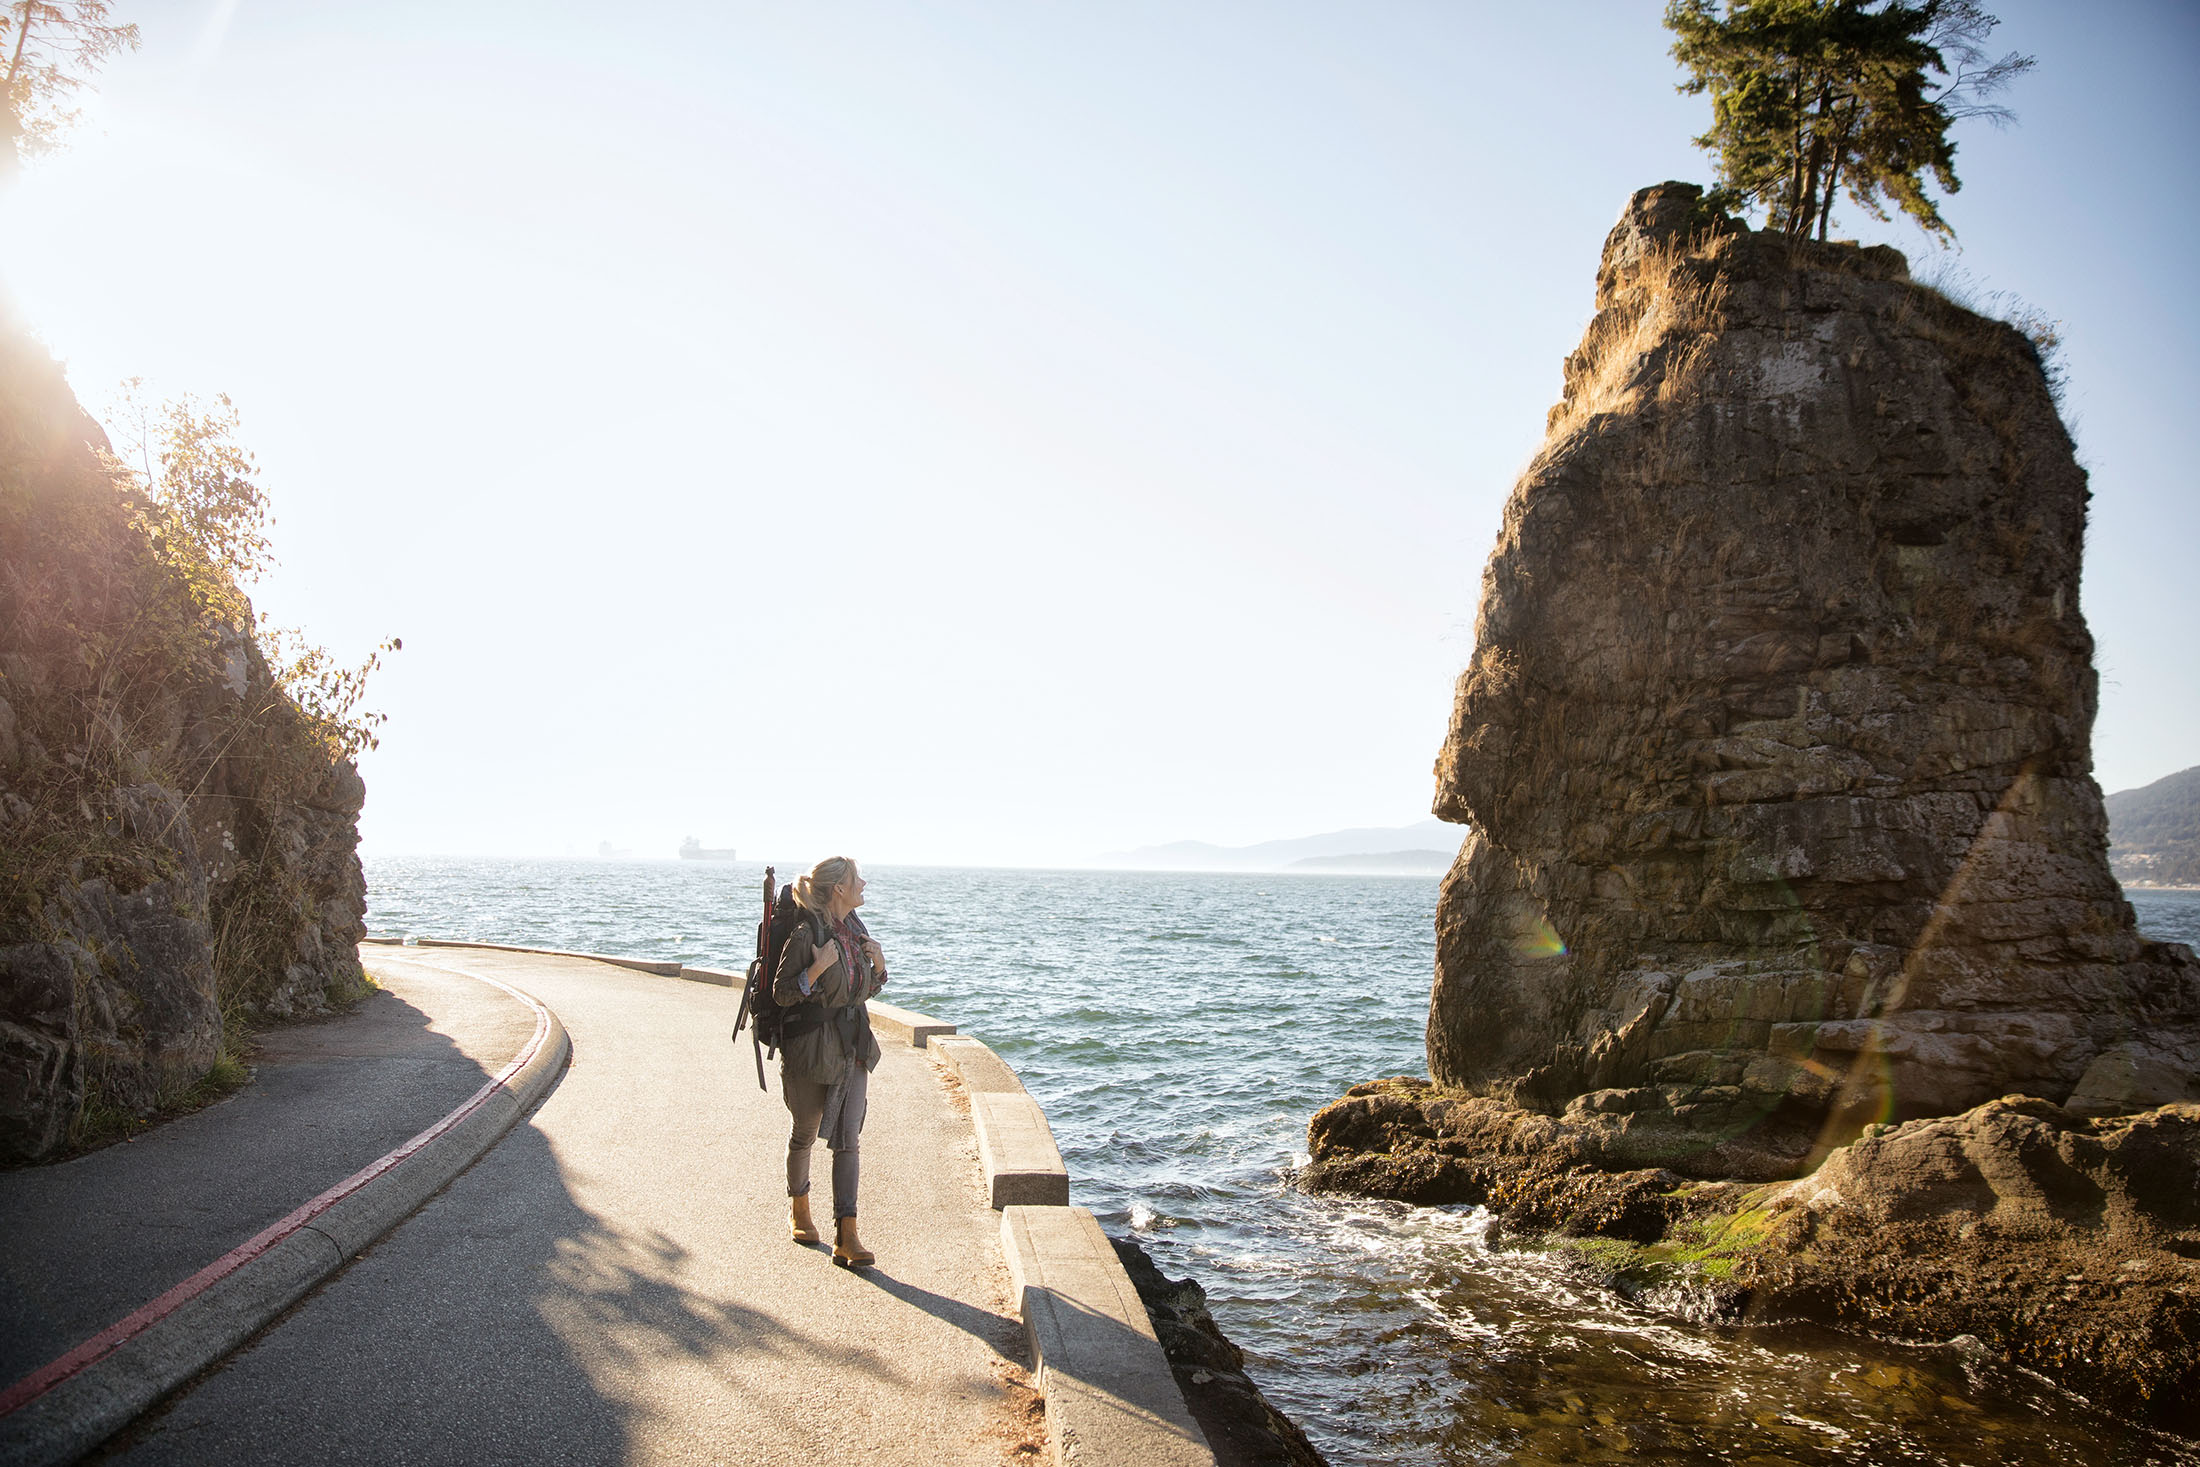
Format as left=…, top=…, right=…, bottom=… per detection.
left=367, top=858, right=2200, bottom=1467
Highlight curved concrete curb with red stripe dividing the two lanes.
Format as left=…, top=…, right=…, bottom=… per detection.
left=0, top=974, right=572, bottom=1467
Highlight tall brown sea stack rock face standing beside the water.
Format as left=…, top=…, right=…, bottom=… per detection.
left=1428, top=185, right=2200, bottom=1174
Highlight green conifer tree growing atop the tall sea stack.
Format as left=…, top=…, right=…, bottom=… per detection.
left=1665, top=0, right=2033, bottom=240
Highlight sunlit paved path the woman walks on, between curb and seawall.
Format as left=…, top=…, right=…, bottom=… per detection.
left=99, top=948, right=1023, bottom=1467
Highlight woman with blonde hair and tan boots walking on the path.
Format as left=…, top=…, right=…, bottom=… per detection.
left=772, top=856, right=887, bottom=1269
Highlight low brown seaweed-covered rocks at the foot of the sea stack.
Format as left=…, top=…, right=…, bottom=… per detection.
left=1300, top=1078, right=2200, bottom=1434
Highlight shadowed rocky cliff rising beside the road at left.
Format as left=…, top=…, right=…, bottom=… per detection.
left=0, top=321, right=365, bottom=1161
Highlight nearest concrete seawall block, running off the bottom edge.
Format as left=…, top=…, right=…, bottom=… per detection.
left=1001, top=1207, right=1214, bottom=1467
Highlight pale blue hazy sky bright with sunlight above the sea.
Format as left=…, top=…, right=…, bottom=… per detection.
left=0, top=0, right=2200, bottom=864
